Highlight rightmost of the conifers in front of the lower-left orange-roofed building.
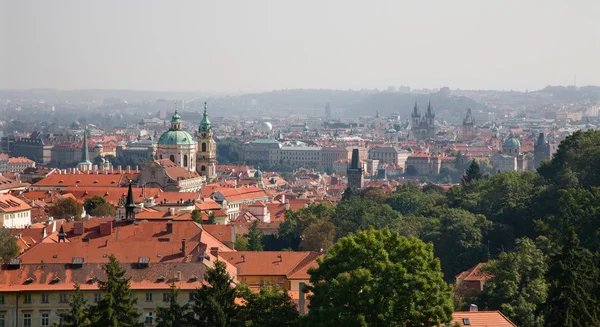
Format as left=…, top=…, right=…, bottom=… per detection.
left=191, top=261, right=237, bottom=327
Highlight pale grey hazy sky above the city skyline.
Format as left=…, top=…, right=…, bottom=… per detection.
left=0, top=0, right=600, bottom=91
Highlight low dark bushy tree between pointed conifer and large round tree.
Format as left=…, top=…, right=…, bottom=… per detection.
left=237, top=284, right=299, bottom=327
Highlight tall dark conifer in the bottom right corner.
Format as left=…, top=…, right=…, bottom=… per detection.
left=546, top=228, right=600, bottom=327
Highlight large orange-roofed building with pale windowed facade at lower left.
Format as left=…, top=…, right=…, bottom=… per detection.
left=0, top=219, right=237, bottom=327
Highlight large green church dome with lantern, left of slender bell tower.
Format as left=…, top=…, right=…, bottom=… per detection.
left=156, top=107, right=197, bottom=173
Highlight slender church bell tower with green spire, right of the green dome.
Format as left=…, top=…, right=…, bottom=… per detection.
left=196, top=102, right=217, bottom=182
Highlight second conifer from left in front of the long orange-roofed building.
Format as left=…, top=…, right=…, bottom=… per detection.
left=90, top=254, right=144, bottom=327
